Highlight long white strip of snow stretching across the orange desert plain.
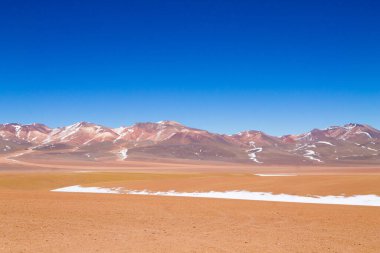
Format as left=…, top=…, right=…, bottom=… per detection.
left=52, top=185, right=380, bottom=206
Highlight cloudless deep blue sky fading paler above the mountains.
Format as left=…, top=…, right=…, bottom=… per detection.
left=0, top=0, right=380, bottom=135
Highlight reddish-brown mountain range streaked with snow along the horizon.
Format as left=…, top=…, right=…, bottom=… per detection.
left=0, top=121, right=380, bottom=166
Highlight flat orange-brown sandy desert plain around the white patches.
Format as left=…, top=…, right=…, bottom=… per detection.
left=0, top=155, right=380, bottom=253
